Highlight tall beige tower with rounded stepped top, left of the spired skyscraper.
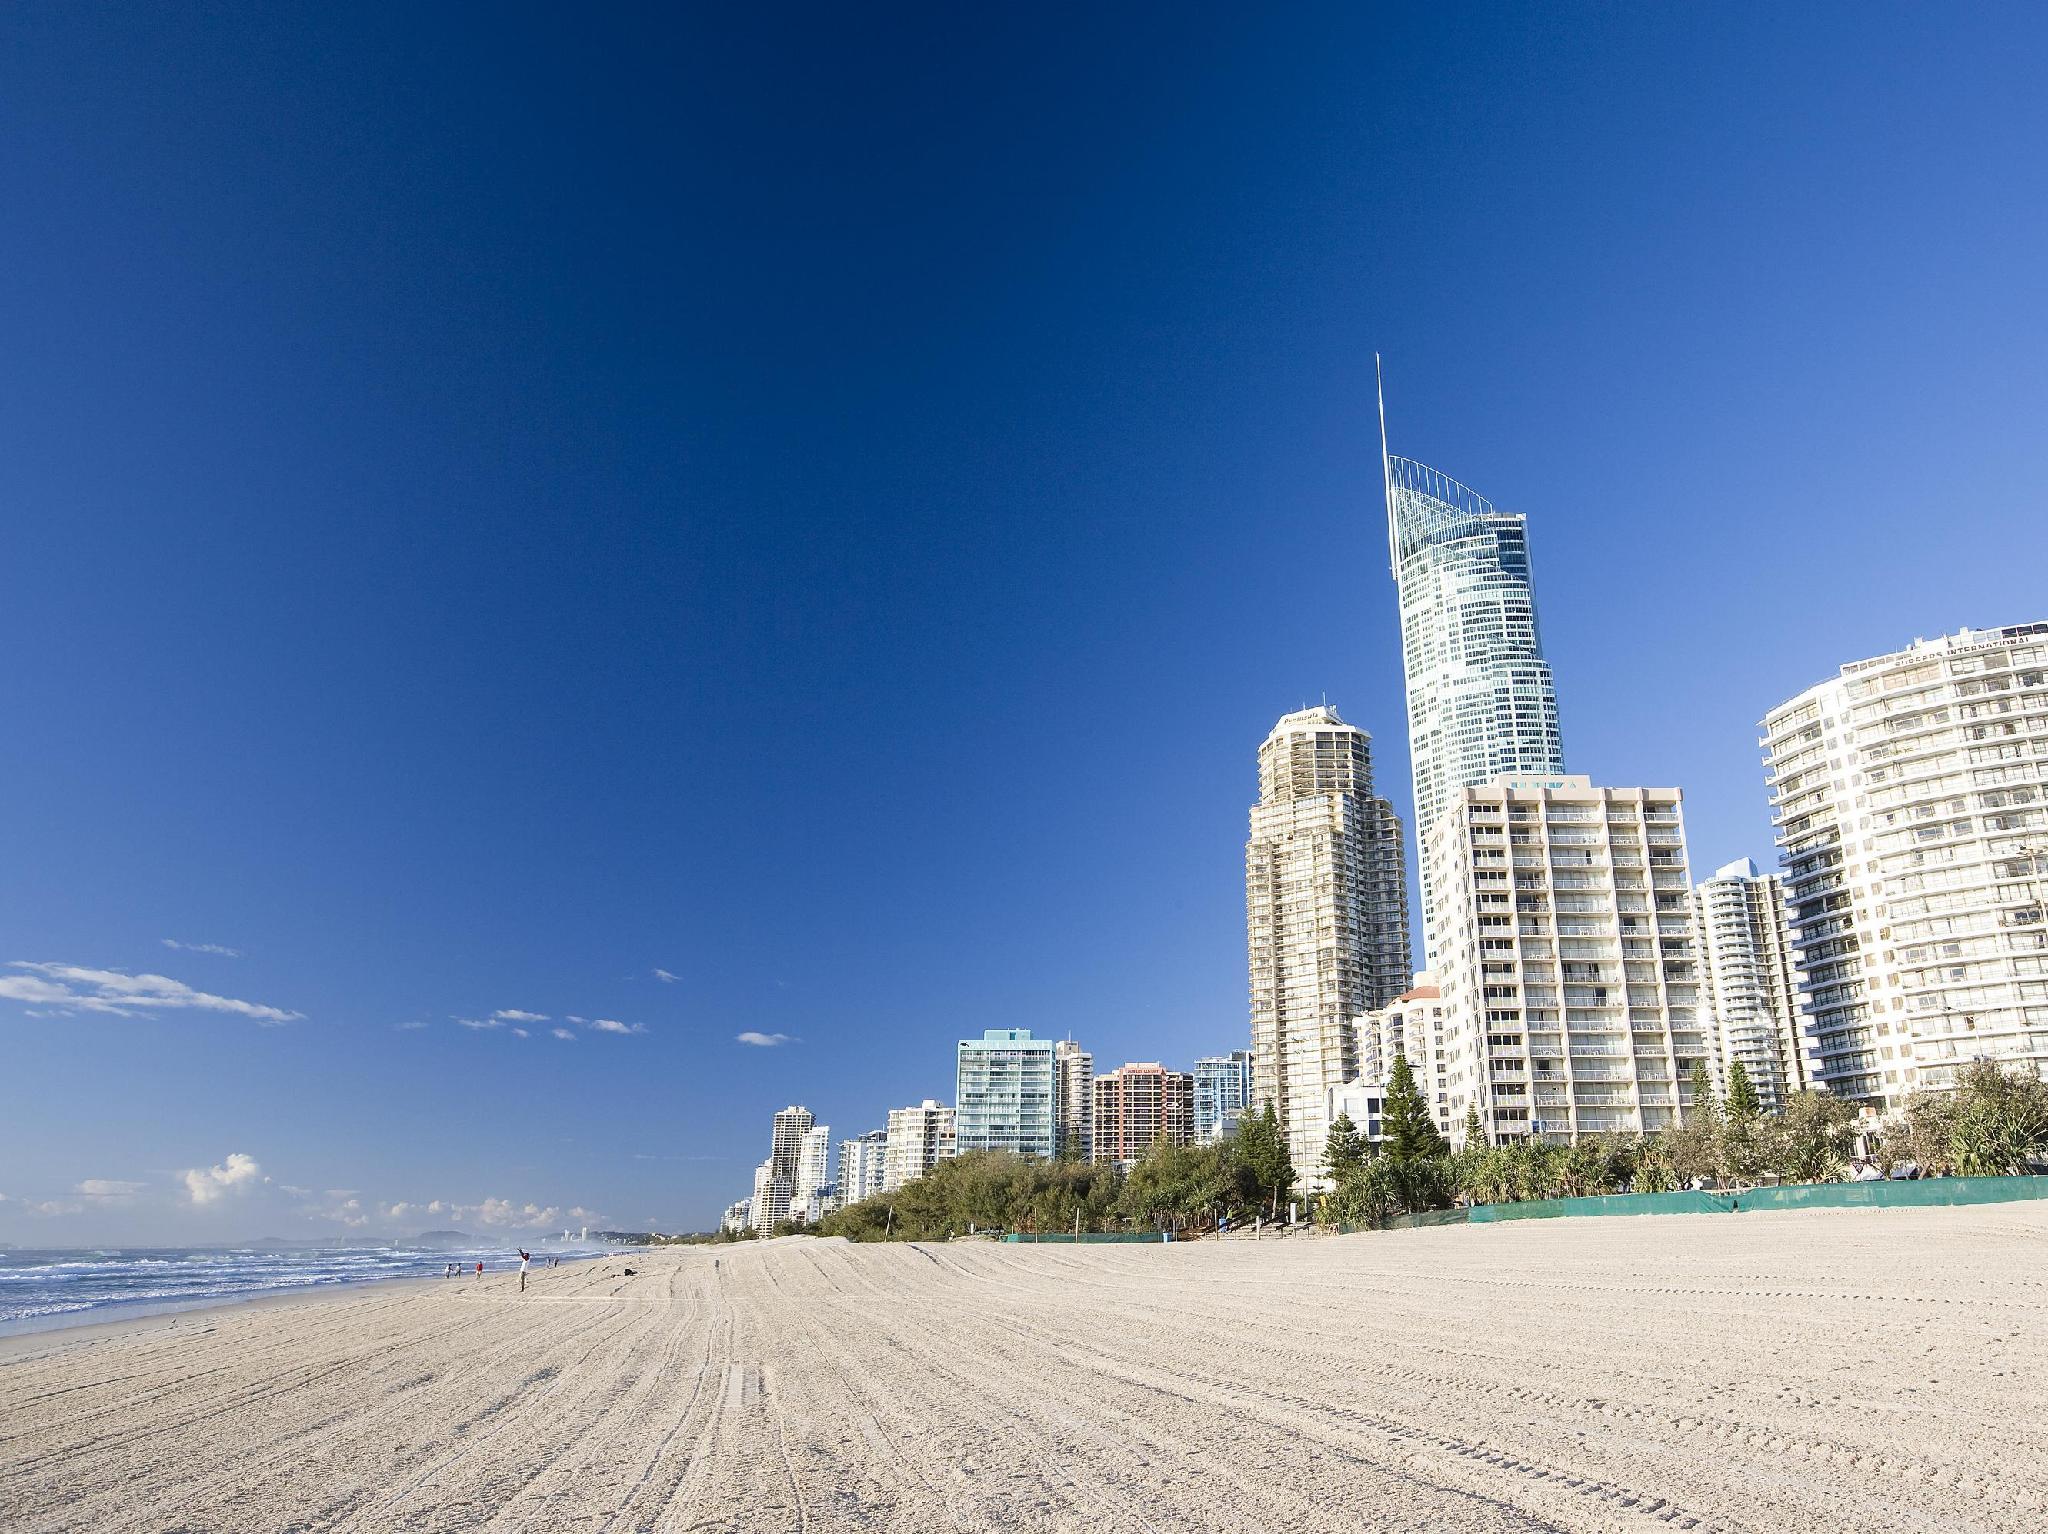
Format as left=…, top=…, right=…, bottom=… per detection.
left=1245, top=707, right=1409, bottom=1167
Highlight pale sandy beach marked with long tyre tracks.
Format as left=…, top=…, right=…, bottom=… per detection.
left=0, top=1204, right=2048, bottom=1534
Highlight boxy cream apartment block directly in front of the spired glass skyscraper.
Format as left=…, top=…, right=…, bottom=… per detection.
left=1430, top=776, right=1710, bottom=1143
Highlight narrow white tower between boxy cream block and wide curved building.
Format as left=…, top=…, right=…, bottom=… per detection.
left=1692, top=858, right=1806, bottom=1110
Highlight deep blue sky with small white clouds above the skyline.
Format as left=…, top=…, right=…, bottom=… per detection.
left=0, top=4, right=2048, bottom=1243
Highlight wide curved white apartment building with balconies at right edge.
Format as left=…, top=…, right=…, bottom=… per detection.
left=1763, top=623, right=2048, bottom=1114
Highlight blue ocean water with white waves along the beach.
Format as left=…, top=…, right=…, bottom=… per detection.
left=0, top=1243, right=604, bottom=1333
